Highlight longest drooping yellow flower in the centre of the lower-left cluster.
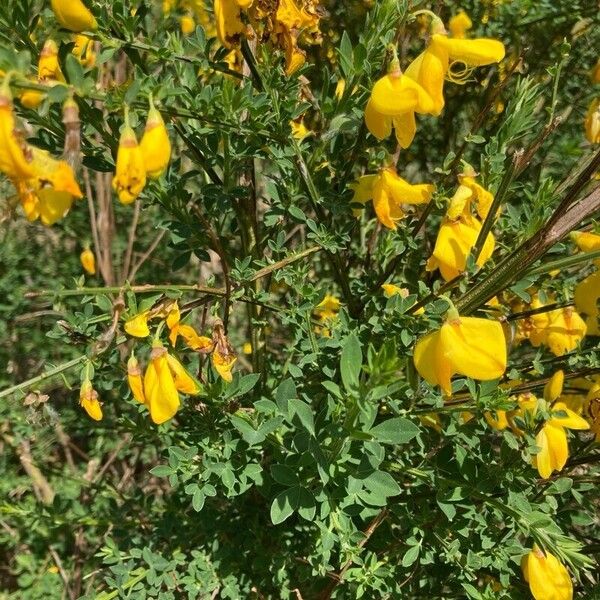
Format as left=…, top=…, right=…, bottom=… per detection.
left=144, top=343, right=180, bottom=425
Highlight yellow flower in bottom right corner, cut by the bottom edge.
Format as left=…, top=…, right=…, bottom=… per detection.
left=521, top=545, right=573, bottom=600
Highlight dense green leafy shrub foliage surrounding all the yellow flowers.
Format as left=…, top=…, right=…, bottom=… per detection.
left=0, top=0, right=600, bottom=600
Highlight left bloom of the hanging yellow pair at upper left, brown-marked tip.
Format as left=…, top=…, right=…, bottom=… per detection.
left=112, top=112, right=146, bottom=204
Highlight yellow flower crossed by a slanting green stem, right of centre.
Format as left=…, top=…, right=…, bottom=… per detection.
left=427, top=214, right=495, bottom=281
